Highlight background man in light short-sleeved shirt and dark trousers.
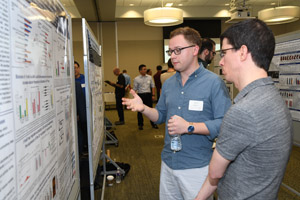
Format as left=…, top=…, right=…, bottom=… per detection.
left=133, top=64, right=158, bottom=130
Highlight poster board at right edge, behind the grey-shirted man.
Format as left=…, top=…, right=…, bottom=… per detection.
left=269, top=31, right=300, bottom=144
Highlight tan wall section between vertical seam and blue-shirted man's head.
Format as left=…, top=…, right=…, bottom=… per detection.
left=118, top=21, right=163, bottom=90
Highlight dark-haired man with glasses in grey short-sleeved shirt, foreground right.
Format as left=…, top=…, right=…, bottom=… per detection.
left=196, top=19, right=292, bottom=200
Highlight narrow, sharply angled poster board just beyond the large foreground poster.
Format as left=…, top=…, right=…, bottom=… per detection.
left=82, top=19, right=105, bottom=199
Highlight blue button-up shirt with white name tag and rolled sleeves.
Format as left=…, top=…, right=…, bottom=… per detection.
left=156, top=64, right=231, bottom=169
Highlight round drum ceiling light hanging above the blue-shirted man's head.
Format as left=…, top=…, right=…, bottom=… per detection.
left=144, top=1, right=183, bottom=26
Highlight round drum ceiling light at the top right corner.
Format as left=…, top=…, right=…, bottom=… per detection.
left=258, top=6, right=300, bottom=25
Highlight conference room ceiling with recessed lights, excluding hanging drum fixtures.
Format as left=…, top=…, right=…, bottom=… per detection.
left=61, top=0, right=300, bottom=22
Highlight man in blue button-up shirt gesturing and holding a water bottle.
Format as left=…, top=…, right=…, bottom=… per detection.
left=123, top=27, right=231, bottom=200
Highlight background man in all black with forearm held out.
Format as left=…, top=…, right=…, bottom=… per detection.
left=105, top=67, right=125, bottom=125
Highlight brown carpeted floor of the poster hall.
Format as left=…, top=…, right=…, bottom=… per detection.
left=95, top=110, right=300, bottom=200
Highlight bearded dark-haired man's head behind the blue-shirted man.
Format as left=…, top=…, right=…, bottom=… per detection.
left=198, top=38, right=216, bottom=68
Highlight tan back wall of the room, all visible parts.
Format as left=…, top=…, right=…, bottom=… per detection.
left=72, top=19, right=300, bottom=94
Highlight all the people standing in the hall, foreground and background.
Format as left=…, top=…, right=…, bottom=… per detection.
left=75, top=19, right=293, bottom=200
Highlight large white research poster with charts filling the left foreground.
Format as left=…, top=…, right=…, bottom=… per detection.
left=0, top=0, right=79, bottom=200
